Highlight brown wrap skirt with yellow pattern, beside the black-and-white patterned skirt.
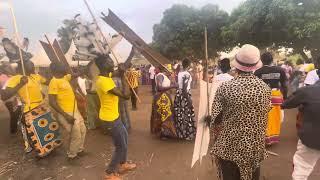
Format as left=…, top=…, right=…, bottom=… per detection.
left=150, top=92, right=177, bottom=138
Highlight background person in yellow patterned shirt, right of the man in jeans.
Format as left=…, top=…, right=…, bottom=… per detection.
left=126, top=65, right=141, bottom=111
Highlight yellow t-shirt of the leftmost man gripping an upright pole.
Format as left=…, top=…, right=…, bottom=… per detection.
left=7, top=74, right=46, bottom=112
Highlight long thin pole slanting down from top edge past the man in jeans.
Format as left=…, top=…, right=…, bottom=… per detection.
left=83, top=0, right=141, bottom=103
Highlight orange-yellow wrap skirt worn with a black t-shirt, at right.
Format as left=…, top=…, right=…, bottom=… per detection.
left=266, top=89, right=283, bottom=145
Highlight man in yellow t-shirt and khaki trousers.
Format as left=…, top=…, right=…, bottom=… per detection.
left=48, top=63, right=86, bottom=160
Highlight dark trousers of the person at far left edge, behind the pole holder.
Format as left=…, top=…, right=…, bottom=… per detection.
left=5, top=101, right=22, bottom=134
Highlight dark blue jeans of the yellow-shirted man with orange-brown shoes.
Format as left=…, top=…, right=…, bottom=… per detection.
left=105, top=119, right=128, bottom=174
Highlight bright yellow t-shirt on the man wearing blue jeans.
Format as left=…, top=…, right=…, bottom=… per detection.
left=96, top=76, right=119, bottom=122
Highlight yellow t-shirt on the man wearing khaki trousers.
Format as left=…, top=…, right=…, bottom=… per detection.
left=48, top=74, right=77, bottom=113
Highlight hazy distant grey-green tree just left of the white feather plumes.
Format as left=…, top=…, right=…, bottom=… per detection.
left=57, top=19, right=76, bottom=53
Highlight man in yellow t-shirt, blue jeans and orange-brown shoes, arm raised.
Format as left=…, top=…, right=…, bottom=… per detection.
left=95, top=55, right=136, bottom=180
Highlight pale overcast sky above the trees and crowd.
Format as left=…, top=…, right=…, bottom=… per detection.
left=0, top=0, right=243, bottom=56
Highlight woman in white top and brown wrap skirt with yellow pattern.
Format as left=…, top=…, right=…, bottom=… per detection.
left=150, top=67, right=177, bottom=138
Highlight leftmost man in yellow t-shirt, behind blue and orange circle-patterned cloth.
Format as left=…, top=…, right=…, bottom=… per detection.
left=1, top=61, right=46, bottom=152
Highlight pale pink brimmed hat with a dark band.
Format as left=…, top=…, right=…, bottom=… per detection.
left=233, top=44, right=262, bottom=72
